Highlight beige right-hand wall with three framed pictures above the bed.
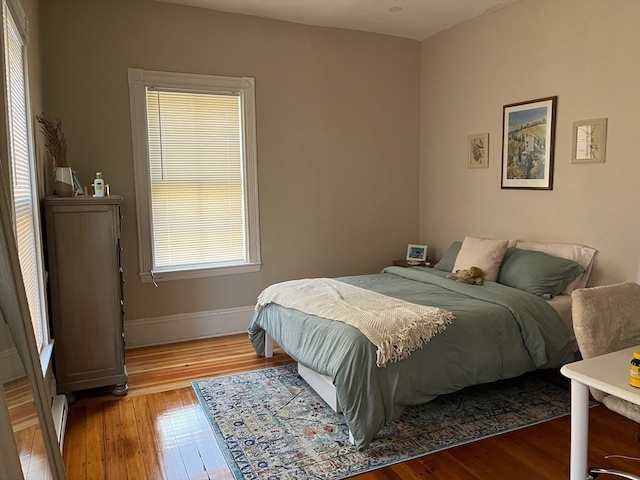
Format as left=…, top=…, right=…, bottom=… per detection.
left=420, top=0, right=640, bottom=284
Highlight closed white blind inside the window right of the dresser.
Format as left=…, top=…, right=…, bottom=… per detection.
left=147, top=89, right=245, bottom=270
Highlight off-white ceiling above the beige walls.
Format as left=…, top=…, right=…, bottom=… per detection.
left=157, top=0, right=519, bottom=40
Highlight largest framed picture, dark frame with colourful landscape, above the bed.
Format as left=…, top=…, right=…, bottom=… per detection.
left=501, top=97, right=558, bottom=190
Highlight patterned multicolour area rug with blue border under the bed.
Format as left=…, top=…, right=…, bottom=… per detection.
left=193, top=364, right=570, bottom=480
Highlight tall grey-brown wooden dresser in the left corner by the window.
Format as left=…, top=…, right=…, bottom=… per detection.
left=44, top=196, right=128, bottom=399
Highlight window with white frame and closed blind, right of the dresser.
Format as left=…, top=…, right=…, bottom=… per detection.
left=129, top=68, right=260, bottom=282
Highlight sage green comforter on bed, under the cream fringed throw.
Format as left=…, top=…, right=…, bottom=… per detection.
left=249, top=267, right=573, bottom=449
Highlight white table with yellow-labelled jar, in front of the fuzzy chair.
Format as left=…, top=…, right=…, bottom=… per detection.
left=560, top=345, right=640, bottom=480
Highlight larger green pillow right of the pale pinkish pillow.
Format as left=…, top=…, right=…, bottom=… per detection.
left=497, top=248, right=584, bottom=299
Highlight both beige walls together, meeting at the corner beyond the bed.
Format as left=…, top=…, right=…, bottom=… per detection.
left=33, top=0, right=640, bottom=342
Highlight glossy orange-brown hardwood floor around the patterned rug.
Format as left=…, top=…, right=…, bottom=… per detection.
left=53, top=334, right=640, bottom=480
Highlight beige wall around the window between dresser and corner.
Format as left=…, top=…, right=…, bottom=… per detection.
left=40, top=0, right=420, bottom=320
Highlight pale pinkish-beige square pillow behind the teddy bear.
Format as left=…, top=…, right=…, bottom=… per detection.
left=453, top=237, right=509, bottom=282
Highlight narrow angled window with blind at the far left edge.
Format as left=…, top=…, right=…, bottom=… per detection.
left=2, top=1, right=50, bottom=360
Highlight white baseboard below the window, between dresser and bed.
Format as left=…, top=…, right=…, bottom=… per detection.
left=124, top=306, right=254, bottom=348
